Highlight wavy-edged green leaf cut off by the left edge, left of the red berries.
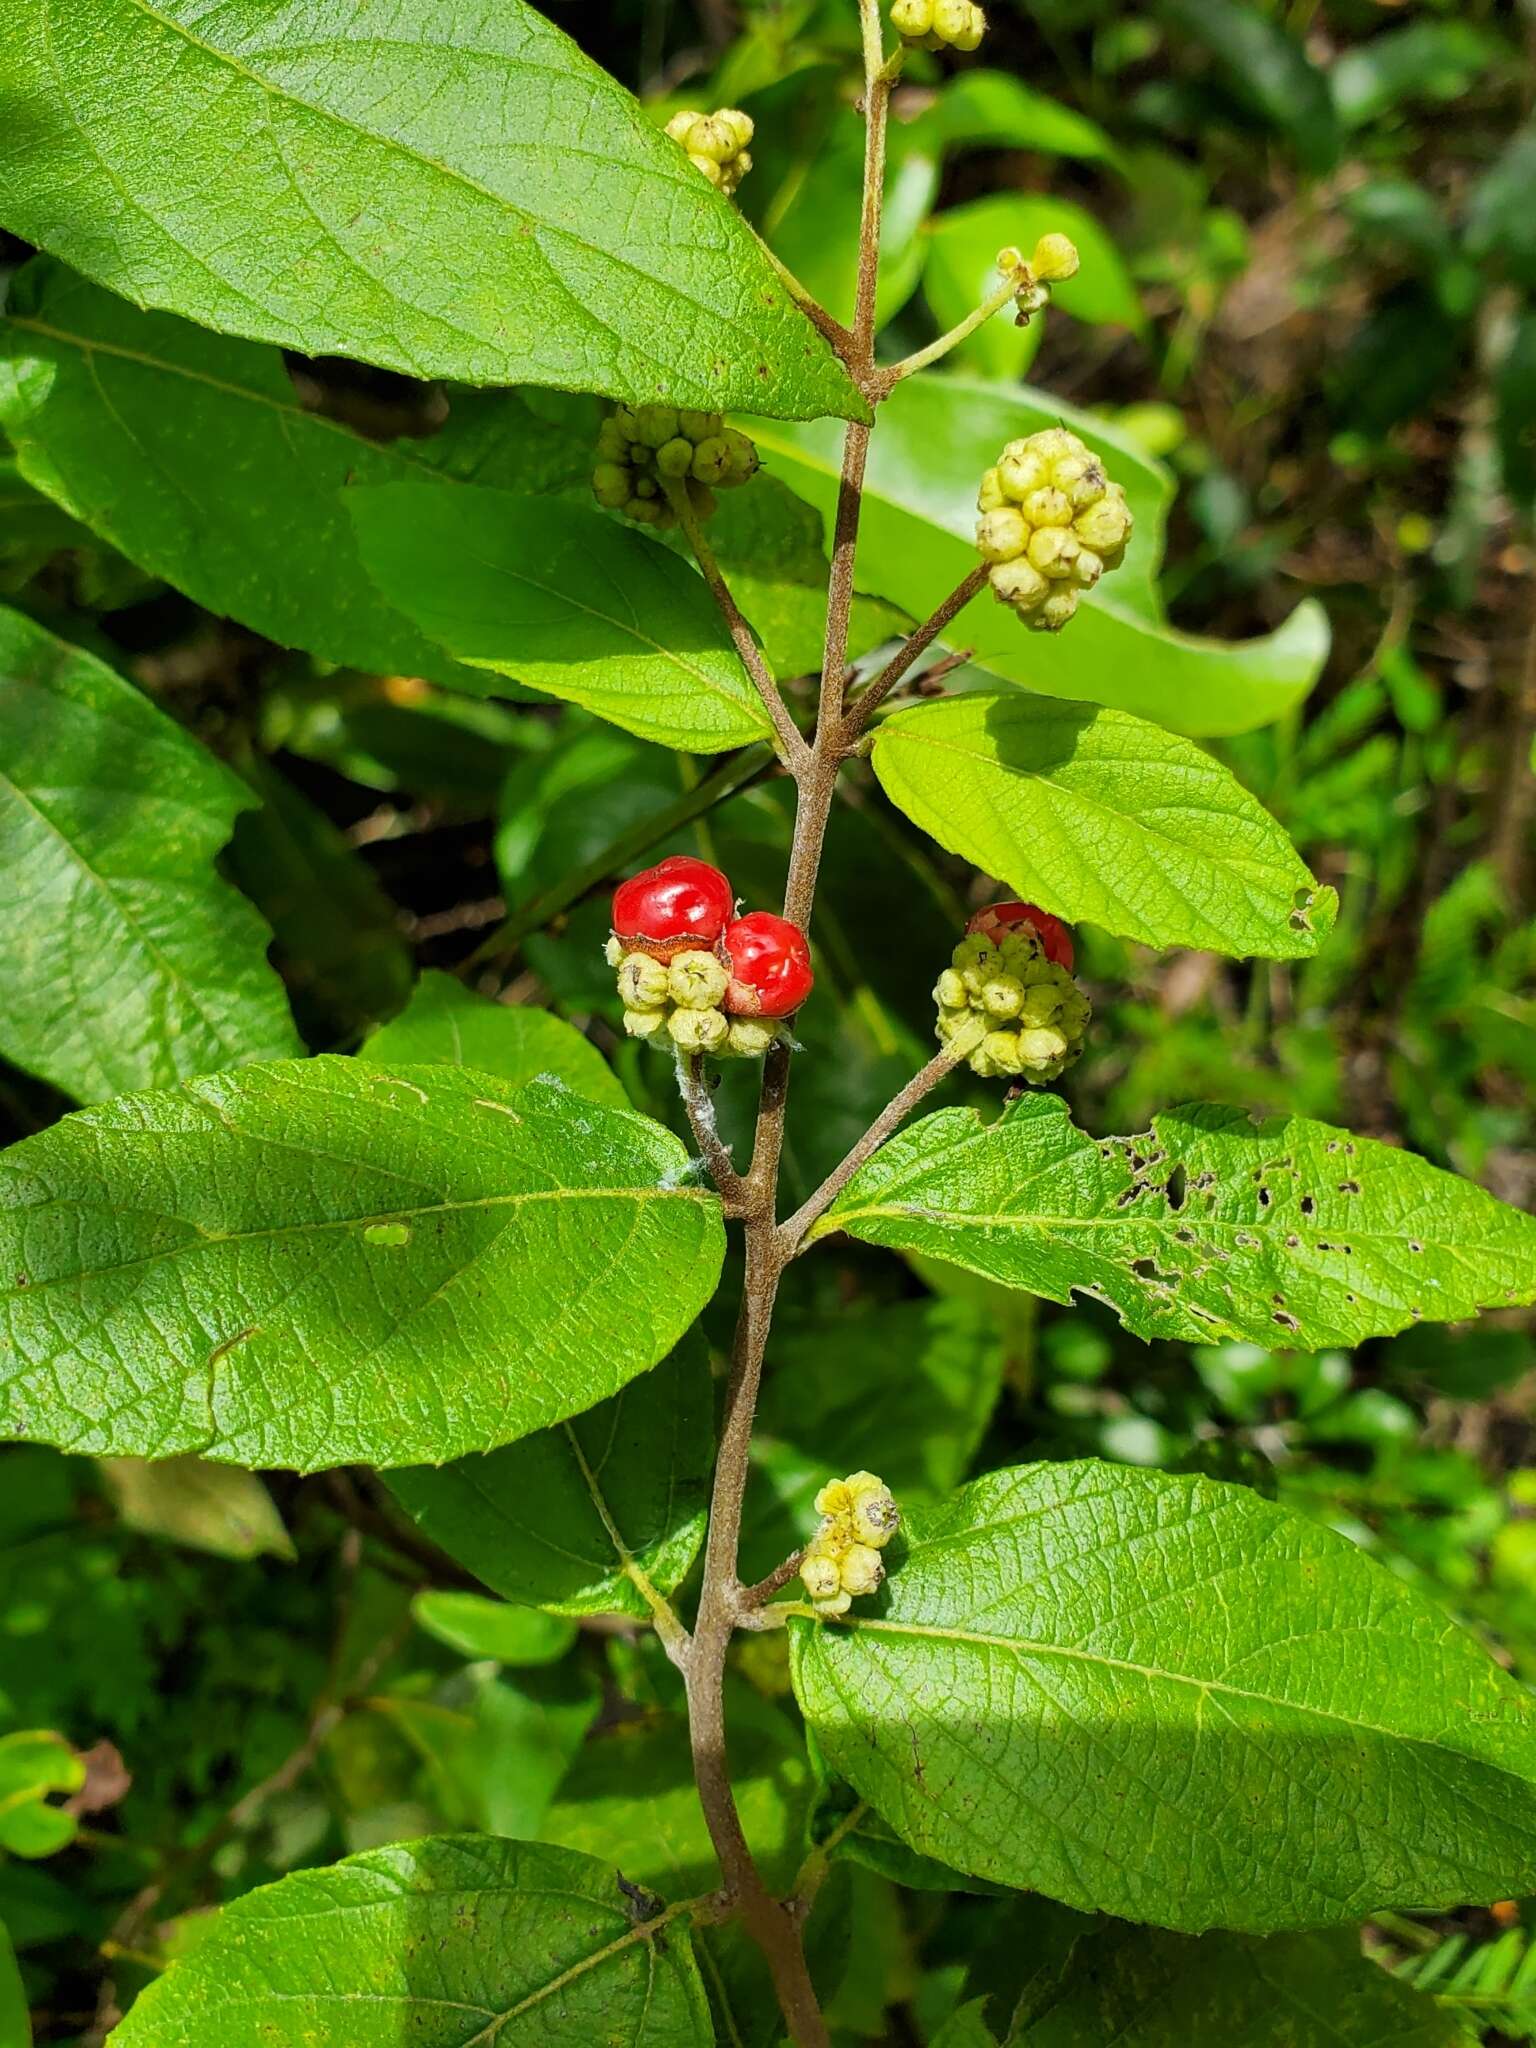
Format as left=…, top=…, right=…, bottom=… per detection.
left=0, top=610, right=299, bottom=1102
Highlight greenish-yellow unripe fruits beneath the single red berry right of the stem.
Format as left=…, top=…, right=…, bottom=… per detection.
left=934, top=928, right=1092, bottom=1081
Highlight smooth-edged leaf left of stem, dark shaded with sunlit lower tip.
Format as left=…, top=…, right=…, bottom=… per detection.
left=346, top=483, right=772, bottom=754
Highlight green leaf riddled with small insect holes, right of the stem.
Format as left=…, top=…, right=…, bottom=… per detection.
left=811, top=1096, right=1536, bottom=1352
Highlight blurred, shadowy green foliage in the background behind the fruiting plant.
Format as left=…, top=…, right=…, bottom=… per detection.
left=0, top=0, right=1536, bottom=2048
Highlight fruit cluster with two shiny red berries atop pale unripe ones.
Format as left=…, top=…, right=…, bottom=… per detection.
left=608, top=854, right=815, bottom=1059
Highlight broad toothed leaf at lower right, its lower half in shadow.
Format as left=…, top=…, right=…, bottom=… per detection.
left=791, top=1462, right=1536, bottom=1931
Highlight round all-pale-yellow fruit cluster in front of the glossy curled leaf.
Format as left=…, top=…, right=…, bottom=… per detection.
left=977, top=426, right=1130, bottom=633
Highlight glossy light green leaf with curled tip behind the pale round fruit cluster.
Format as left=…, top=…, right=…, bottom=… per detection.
left=754, top=373, right=1327, bottom=737
